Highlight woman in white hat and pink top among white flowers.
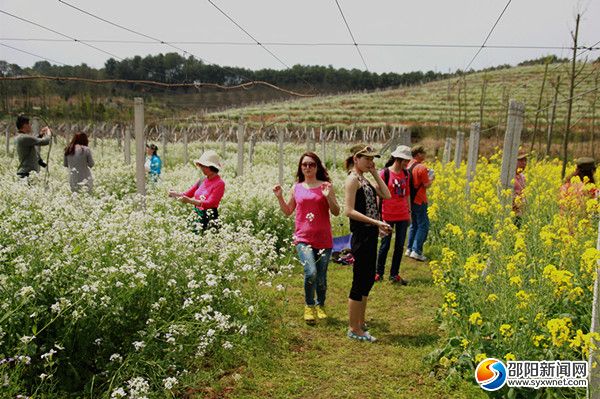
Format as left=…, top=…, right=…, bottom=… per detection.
left=169, top=150, right=225, bottom=233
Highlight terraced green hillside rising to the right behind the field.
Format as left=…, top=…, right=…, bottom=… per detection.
left=203, top=63, right=600, bottom=137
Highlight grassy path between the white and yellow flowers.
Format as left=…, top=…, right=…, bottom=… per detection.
left=224, top=255, right=486, bottom=399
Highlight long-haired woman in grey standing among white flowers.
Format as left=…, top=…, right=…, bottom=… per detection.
left=63, top=133, right=94, bottom=192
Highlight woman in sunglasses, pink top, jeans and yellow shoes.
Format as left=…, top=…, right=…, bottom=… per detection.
left=273, top=152, right=340, bottom=324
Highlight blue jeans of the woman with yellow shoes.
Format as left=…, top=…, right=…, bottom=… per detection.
left=296, top=242, right=331, bottom=306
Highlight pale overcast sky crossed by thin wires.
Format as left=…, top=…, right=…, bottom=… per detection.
left=0, top=0, right=600, bottom=73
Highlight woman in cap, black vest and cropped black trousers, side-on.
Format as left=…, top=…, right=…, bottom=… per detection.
left=344, top=144, right=392, bottom=342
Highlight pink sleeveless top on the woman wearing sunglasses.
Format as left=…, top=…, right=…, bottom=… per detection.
left=294, top=183, right=333, bottom=249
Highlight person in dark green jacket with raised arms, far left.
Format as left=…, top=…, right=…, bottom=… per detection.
left=15, top=115, right=52, bottom=178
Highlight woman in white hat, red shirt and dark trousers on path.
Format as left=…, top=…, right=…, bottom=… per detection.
left=375, top=145, right=412, bottom=285
